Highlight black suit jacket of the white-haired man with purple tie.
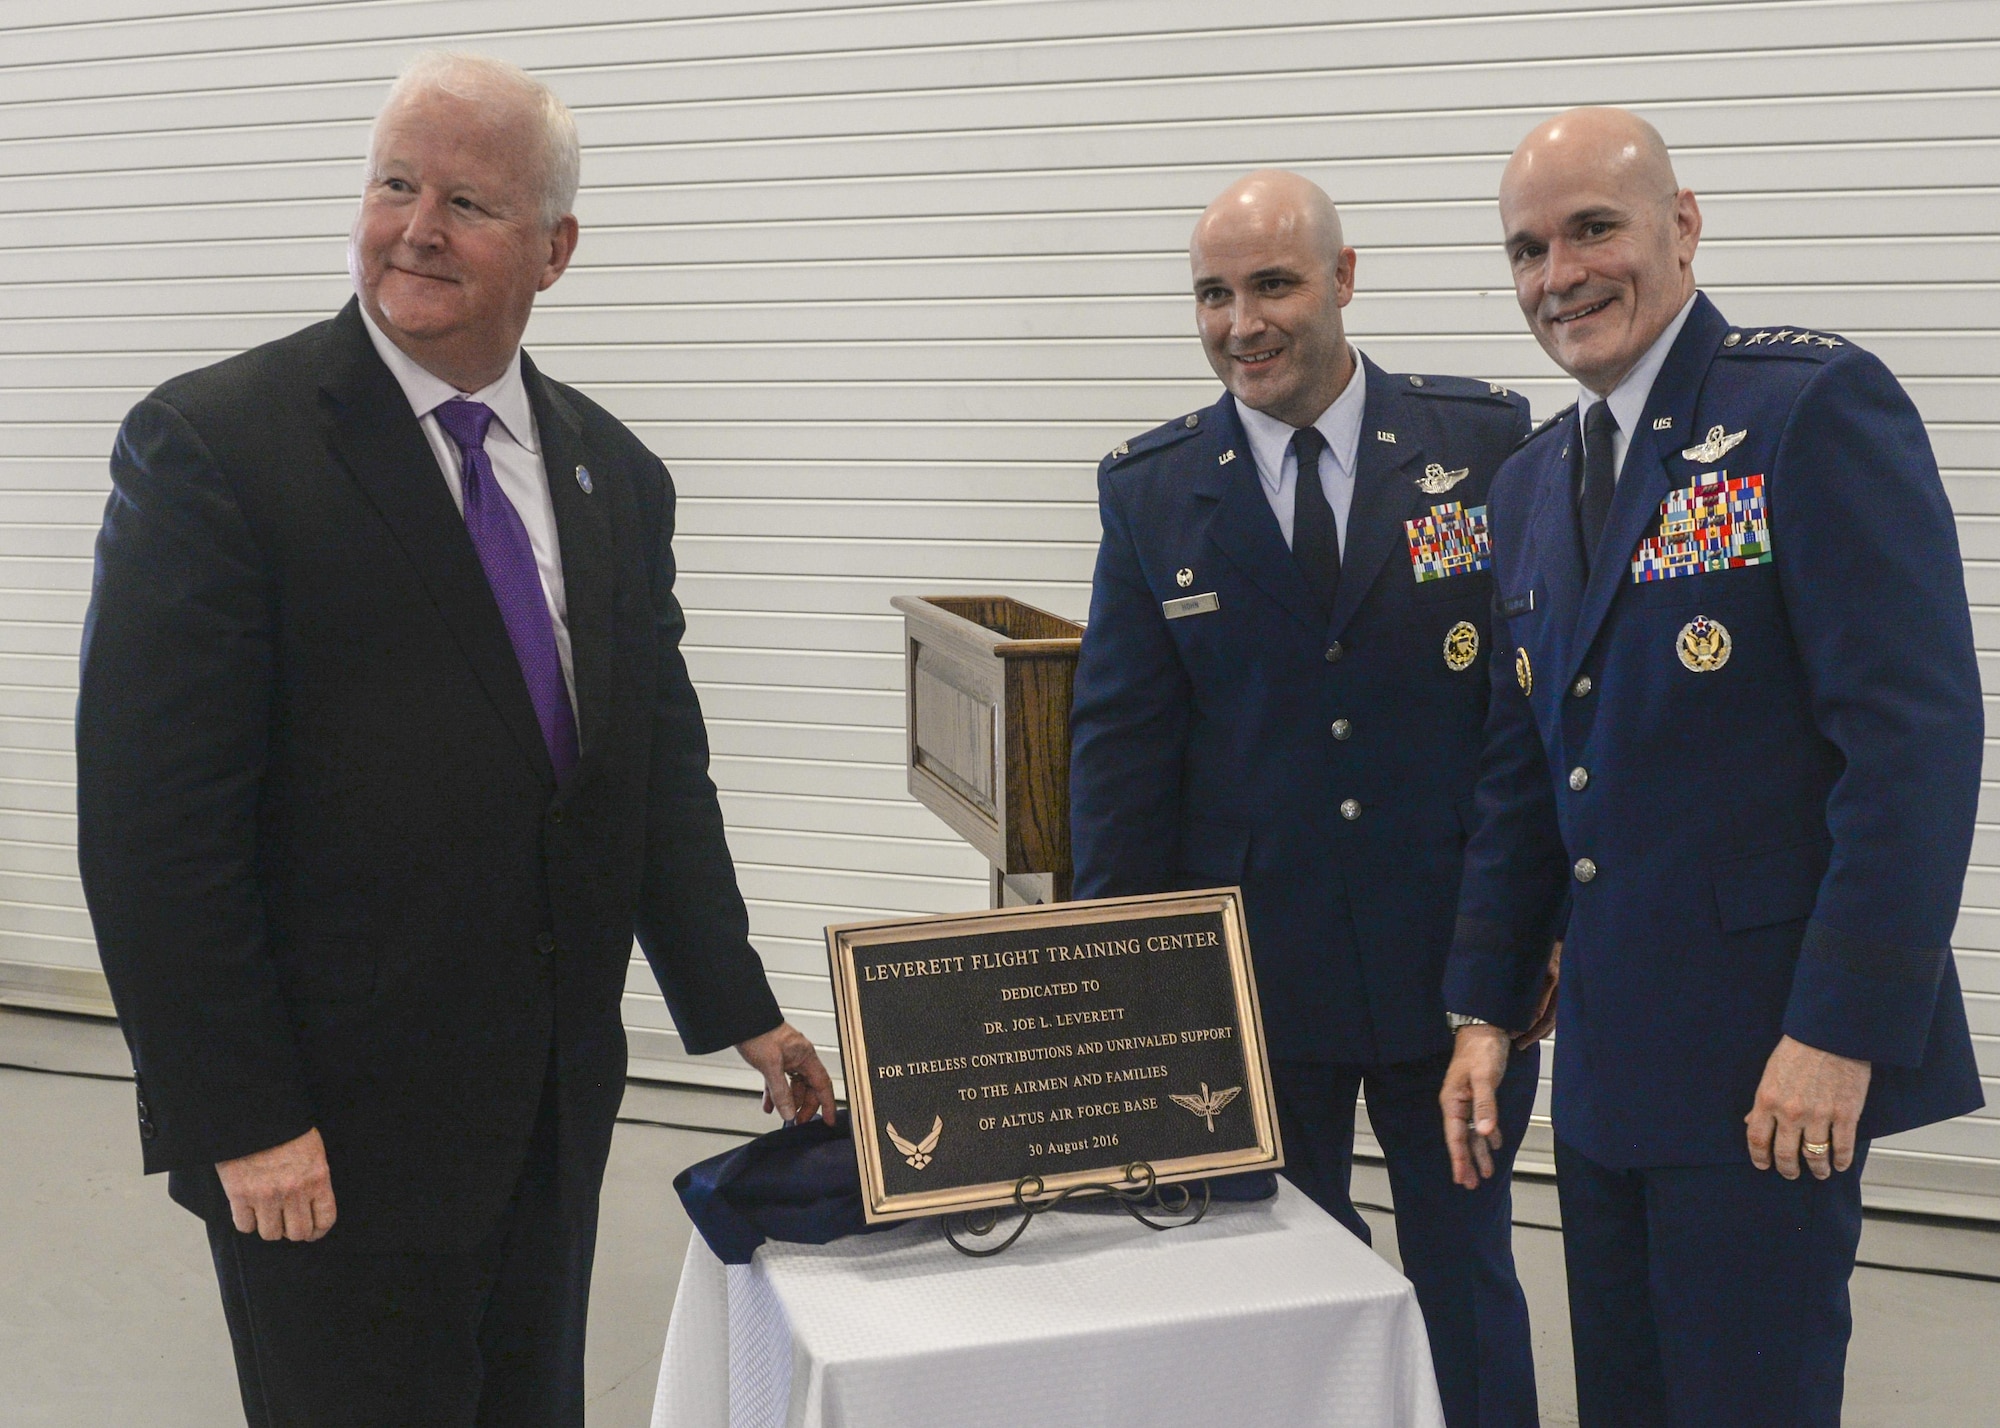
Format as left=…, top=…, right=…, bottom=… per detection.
left=76, top=302, right=780, bottom=1250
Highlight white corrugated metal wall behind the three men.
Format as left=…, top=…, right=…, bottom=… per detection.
left=0, top=0, right=2000, bottom=1216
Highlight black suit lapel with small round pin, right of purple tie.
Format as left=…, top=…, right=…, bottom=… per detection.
left=520, top=352, right=616, bottom=780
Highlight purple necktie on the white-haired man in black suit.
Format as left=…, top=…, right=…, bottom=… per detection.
left=432, top=396, right=576, bottom=780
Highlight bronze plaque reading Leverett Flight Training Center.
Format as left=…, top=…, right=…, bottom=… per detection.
left=826, top=888, right=1284, bottom=1222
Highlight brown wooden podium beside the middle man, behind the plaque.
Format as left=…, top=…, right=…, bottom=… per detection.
left=892, top=596, right=1084, bottom=908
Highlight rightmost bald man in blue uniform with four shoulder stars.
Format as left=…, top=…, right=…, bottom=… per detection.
left=1442, top=110, right=1982, bottom=1428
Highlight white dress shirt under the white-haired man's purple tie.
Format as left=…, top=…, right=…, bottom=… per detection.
left=360, top=308, right=576, bottom=714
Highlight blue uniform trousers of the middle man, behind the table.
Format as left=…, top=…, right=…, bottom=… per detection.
left=1270, top=1046, right=1542, bottom=1428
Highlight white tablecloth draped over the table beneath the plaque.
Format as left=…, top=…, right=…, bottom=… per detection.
left=652, top=1180, right=1444, bottom=1428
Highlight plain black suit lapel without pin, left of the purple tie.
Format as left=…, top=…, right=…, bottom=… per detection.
left=320, top=302, right=554, bottom=784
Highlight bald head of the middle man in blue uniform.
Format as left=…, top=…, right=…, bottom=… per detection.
left=1188, top=168, right=1354, bottom=426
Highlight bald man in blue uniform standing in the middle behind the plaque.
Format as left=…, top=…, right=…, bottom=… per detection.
left=1070, top=172, right=1548, bottom=1428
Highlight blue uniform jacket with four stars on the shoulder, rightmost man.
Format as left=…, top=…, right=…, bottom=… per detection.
left=1446, top=296, right=1984, bottom=1166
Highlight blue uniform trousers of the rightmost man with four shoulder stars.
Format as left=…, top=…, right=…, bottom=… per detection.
left=1556, top=1140, right=1868, bottom=1428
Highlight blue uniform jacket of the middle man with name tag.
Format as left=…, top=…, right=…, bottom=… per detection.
left=1070, top=362, right=1546, bottom=1062
